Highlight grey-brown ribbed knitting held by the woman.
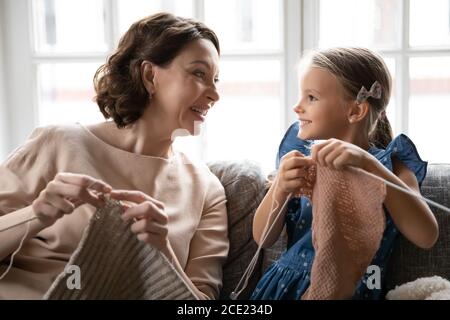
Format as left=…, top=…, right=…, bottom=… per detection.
left=43, top=200, right=197, bottom=300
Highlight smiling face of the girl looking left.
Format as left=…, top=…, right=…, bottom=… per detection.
left=294, top=66, right=349, bottom=140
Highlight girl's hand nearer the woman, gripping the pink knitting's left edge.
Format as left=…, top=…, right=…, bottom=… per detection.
left=275, top=150, right=313, bottom=197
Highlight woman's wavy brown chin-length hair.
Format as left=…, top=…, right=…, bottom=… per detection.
left=94, top=13, right=220, bottom=128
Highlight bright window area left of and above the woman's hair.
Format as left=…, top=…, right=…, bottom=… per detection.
left=31, top=0, right=193, bottom=125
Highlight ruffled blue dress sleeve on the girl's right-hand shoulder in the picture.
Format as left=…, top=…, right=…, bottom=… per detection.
left=380, top=134, right=428, bottom=186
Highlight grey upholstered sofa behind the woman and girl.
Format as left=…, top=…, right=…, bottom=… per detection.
left=209, top=161, right=450, bottom=299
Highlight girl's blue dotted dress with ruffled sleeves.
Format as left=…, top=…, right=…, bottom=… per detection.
left=251, top=122, right=427, bottom=300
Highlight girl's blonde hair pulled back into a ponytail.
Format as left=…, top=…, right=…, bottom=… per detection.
left=307, top=48, right=393, bottom=149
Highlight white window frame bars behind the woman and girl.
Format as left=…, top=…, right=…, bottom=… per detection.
left=0, top=0, right=450, bottom=158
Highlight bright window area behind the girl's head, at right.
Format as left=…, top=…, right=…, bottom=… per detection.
left=304, top=0, right=450, bottom=162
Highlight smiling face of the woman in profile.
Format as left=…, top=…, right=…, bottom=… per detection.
left=149, top=39, right=219, bottom=135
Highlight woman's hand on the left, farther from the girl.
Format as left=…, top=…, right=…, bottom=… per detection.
left=32, top=173, right=112, bottom=227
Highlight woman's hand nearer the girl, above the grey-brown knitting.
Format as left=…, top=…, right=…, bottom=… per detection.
left=110, top=190, right=169, bottom=253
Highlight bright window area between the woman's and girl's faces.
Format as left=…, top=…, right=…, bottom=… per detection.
left=204, top=0, right=284, bottom=172
